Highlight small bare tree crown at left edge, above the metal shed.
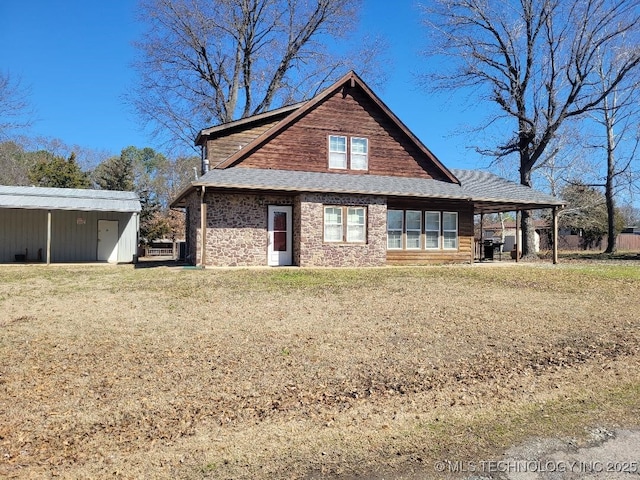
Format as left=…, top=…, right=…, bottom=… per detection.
left=0, top=72, right=33, bottom=141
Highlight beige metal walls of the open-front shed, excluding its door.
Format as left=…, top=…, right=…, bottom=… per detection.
left=0, top=209, right=138, bottom=263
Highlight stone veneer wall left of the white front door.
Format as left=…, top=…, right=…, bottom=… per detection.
left=198, top=193, right=295, bottom=267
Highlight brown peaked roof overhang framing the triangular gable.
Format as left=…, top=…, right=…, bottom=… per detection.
left=211, top=71, right=460, bottom=183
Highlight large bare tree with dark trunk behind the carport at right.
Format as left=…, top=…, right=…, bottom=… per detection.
left=424, top=0, right=640, bottom=256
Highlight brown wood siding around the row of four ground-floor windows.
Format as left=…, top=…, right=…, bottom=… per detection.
left=387, top=198, right=474, bottom=265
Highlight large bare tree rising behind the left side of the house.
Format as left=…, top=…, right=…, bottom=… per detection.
left=128, top=0, right=376, bottom=150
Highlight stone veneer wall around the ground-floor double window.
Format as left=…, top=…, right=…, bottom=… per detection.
left=294, top=193, right=387, bottom=267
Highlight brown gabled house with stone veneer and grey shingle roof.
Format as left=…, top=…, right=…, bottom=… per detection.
left=172, top=72, right=562, bottom=267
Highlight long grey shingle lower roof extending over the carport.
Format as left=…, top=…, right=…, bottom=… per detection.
left=179, top=167, right=563, bottom=212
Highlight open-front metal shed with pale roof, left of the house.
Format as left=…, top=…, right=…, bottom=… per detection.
left=0, top=186, right=141, bottom=264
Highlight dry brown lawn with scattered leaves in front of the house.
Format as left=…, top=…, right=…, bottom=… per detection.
left=0, top=264, right=640, bottom=479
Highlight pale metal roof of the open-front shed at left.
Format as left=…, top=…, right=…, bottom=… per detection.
left=0, top=186, right=141, bottom=212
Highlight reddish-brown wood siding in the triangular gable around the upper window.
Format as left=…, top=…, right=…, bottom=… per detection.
left=239, top=87, right=444, bottom=180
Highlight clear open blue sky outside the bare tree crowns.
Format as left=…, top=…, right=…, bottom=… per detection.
left=0, top=0, right=484, bottom=168
